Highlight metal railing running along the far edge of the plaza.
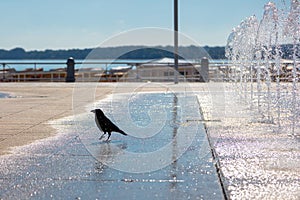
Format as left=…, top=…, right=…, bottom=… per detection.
left=0, top=60, right=300, bottom=82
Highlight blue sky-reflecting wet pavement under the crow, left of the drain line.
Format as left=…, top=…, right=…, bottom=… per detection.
left=0, top=93, right=224, bottom=199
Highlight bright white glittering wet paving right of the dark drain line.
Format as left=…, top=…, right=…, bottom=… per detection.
left=198, top=84, right=300, bottom=200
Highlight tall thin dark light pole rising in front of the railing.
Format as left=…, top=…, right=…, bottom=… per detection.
left=174, top=0, right=178, bottom=84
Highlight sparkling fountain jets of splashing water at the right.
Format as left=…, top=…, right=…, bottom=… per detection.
left=226, top=0, right=300, bottom=136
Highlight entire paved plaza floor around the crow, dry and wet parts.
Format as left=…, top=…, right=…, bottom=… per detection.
left=0, top=83, right=300, bottom=200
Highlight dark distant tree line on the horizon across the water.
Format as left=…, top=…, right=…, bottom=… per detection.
left=0, top=46, right=225, bottom=59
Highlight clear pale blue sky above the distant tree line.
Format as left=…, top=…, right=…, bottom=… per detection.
left=0, top=0, right=289, bottom=50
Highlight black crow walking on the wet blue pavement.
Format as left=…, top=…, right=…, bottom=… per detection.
left=91, top=109, right=127, bottom=141
